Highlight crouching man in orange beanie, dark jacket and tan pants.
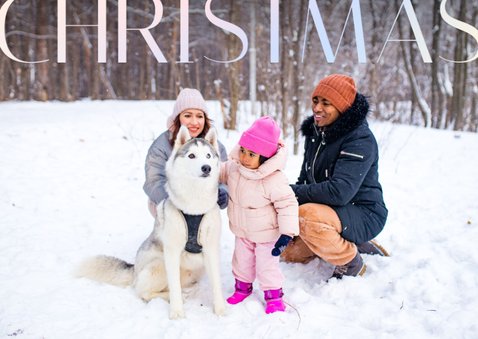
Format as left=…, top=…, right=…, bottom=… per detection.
left=282, top=74, right=388, bottom=278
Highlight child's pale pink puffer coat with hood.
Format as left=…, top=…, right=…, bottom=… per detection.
left=220, top=146, right=299, bottom=243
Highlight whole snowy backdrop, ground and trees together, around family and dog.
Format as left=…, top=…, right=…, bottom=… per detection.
left=0, top=0, right=478, bottom=339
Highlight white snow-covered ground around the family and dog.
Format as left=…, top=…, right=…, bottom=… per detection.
left=0, top=101, right=478, bottom=339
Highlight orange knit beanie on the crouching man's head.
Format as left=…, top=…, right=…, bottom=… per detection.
left=312, top=74, right=357, bottom=113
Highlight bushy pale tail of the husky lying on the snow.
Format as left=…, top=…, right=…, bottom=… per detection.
left=75, top=255, right=134, bottom=287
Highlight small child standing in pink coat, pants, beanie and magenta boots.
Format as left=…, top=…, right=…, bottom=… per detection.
left=220, top=117, right=299, bottom=313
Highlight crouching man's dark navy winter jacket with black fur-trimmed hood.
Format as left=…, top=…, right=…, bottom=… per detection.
left=292, top=93, right=388, bottom=244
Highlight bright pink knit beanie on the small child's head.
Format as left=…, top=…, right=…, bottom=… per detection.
left=239, top=116, right=280, bottom=158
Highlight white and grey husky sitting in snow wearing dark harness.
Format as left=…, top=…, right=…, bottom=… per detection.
left=76, top=126, right=225, bottom=319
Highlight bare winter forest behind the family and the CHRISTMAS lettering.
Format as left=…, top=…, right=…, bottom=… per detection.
left=0, top=0, right=478, bottom=153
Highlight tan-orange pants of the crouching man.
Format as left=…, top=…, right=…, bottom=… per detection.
left=281, top=203, right=357, bottom=265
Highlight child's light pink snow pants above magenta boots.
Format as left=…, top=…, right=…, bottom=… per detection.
left=232, top=237, right=284, bottom=291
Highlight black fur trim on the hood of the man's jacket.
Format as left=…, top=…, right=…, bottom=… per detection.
left=300, top=93, right=370, bottom=142
